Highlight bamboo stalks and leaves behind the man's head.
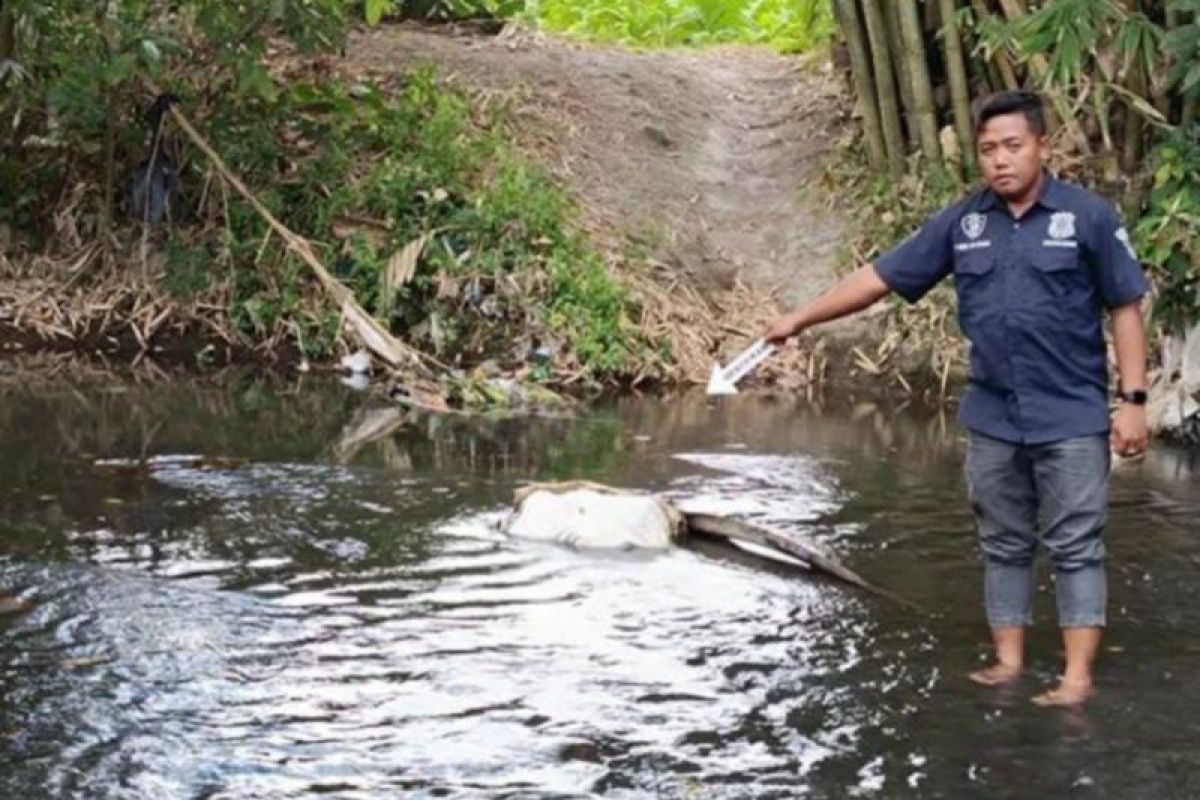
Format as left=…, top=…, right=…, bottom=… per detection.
left=833, top=0, right=1200, bottom=330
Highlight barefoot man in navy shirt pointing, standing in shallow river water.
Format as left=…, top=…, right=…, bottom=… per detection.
left=764, top=92, right=1148, bottom=705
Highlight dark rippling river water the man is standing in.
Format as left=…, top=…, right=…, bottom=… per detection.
left=0, top=379, right=1200, bottom=800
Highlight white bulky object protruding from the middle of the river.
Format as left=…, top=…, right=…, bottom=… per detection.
left=504, top=486, right=682, bottom=549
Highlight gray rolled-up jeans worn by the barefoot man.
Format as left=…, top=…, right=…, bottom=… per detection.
left=966, top=432, right=1110, bottom=627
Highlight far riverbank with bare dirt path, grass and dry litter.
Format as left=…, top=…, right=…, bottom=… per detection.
left=7, top=24, right=1195, bottom=431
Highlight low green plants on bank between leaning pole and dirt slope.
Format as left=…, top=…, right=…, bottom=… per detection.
left=208, top=72, right=641, bottom=377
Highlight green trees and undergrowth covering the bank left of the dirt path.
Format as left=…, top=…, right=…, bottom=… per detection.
left=0, top=0, right=659, bottom=380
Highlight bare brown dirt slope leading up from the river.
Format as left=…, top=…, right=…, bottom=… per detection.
left=347, top=26, right=846, bottom=302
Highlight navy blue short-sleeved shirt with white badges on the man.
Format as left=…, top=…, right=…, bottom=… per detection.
left=875, top=174, right=1150, bottom=444
